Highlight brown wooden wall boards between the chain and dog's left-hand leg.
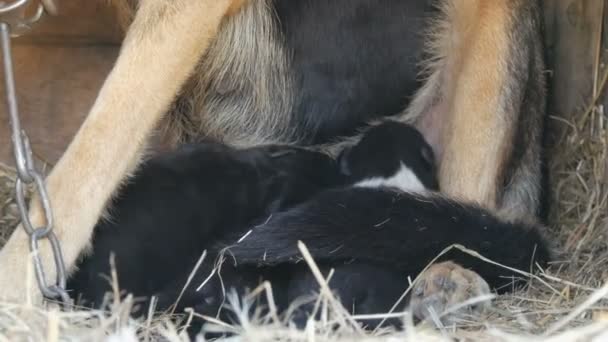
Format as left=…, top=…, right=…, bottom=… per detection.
left=0, top=0, right=119, bottom=165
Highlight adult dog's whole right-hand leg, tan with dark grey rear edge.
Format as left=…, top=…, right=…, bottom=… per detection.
left=406, top=0, right=545, bottom=217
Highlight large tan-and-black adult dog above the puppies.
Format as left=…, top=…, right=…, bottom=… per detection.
left=0, top=0, right=544, bottom=300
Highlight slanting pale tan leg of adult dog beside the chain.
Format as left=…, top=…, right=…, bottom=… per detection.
left=0, top=0, right=244, bottom=300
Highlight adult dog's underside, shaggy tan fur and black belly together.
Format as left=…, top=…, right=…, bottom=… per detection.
left=174, top=0, right=437, bottom=146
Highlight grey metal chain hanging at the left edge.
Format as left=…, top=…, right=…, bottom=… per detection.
left=0, top=0, right=71, bottom=308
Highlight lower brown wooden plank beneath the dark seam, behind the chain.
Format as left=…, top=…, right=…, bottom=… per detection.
left=0, top=45, right=116, bottom=165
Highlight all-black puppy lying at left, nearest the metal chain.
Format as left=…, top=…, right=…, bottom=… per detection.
left=68, top=143, right=343, bottom=306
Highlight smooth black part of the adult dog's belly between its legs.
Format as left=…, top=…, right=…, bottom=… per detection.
left=274, top=0, right=434, bottom=143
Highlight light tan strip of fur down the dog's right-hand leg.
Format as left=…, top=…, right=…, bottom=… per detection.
left=439, top=0, right=511, bottom=209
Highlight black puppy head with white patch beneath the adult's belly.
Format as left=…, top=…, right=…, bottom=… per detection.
left=338, top=121, right=439, bottom=192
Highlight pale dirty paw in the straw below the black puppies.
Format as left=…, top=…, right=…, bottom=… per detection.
left=410, top=262, right=491, bottom=325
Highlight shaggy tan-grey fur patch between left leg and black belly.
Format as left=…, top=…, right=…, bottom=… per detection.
left=167, top=0, right=295, bottom=146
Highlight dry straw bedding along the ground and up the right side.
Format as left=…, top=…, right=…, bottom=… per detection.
left=0, top=48, right=608, bottom=341
